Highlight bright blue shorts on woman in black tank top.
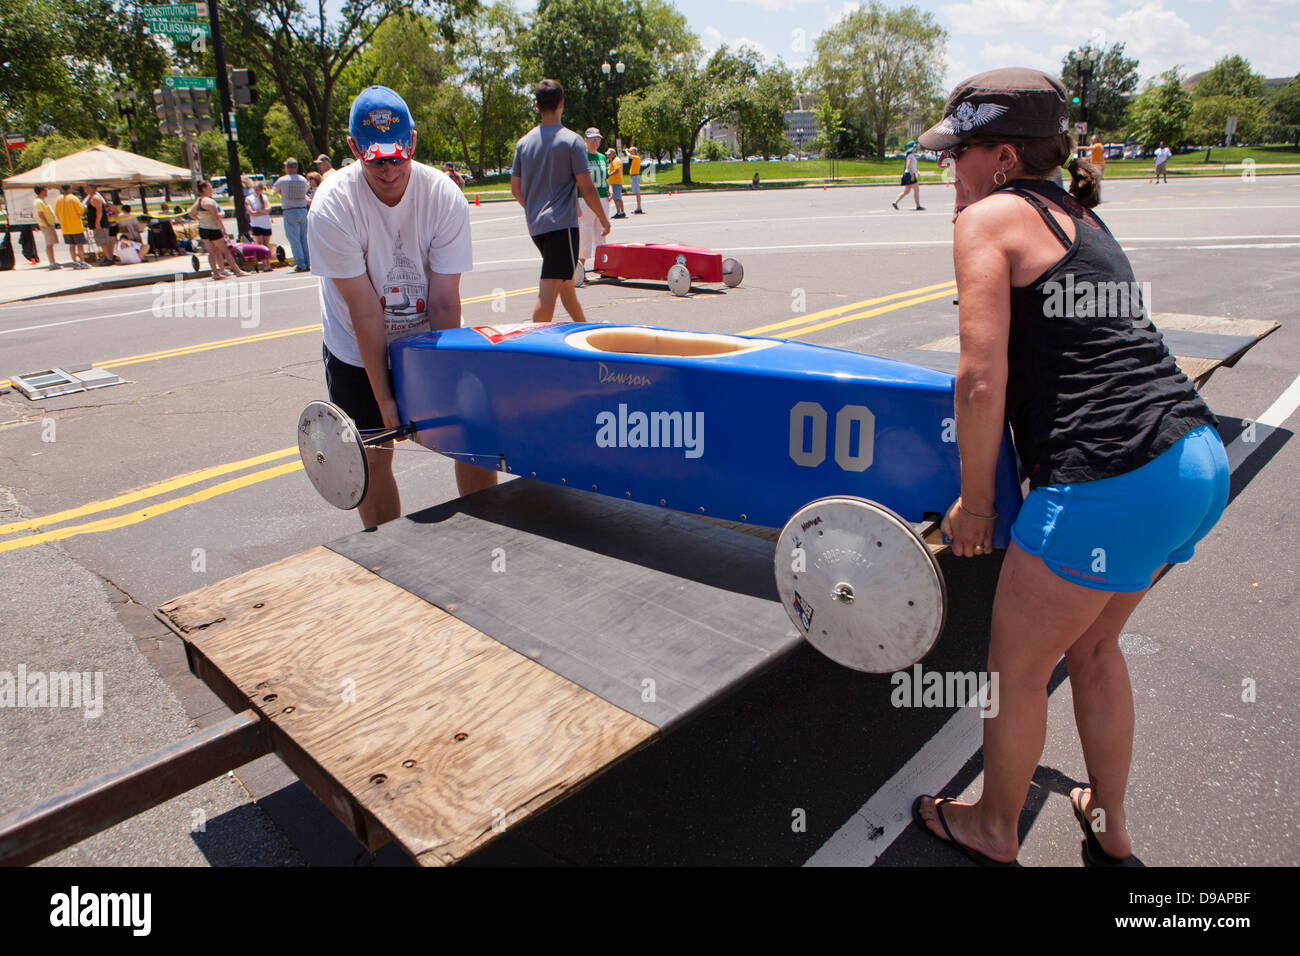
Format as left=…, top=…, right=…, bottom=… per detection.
left=1011, top=425, right=1231, bottom=592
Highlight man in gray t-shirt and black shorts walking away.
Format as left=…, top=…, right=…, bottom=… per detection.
left=510, top=79, right=610, bottom=323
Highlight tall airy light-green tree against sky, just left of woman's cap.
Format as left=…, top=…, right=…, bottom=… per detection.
left=810, top=0, right=948, bottom=153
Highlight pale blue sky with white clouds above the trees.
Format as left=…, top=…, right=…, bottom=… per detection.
left=515, top=0, right=1300, bottom=90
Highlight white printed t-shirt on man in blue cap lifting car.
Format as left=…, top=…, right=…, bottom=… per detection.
left=307, top=163, right=473, bottom=367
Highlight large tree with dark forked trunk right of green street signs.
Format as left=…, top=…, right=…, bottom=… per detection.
left=222, top=0, right=477, bottom=155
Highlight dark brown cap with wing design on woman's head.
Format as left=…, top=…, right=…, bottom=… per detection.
left=919, top=66, right=1070, bottom=150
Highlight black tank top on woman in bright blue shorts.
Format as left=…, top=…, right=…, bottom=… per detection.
left=1000, top=179, right=1217, bottom=488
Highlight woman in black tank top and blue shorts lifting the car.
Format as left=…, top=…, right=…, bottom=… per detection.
left=913, top=69, right=1229, bottom=864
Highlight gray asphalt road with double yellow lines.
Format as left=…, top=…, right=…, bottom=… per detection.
left=0, top=177, right=1300, bottom=866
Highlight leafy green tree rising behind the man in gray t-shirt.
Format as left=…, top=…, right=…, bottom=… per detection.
left=525, top=0, right=698, bottom=135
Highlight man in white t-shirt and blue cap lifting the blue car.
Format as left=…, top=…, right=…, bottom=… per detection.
left=307, top=86, right=497, bottom=527
